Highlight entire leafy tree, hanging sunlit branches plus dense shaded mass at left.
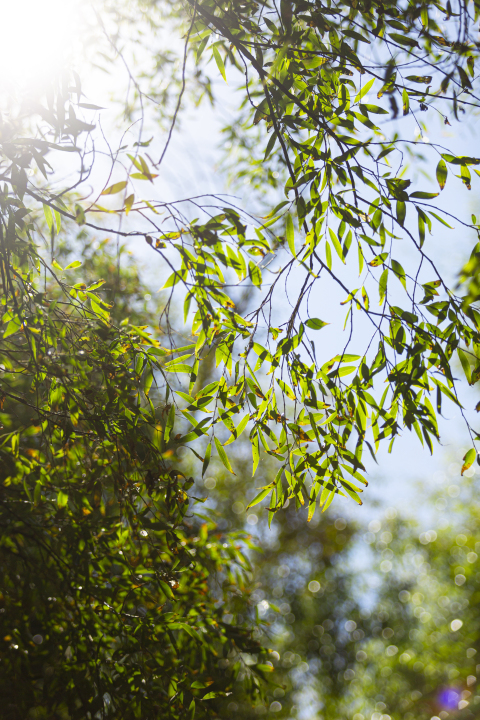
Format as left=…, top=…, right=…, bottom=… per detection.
left=0, top=0, right=480, bottom=718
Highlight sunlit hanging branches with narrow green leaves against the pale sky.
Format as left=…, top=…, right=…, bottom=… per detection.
left=68, top=0, right=480, bottom=518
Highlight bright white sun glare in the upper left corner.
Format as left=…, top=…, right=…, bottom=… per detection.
left=0, top=0, right=80, bottom=90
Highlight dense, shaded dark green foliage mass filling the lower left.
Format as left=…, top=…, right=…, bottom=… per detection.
left=0, top=233, right=261, bottom=718
